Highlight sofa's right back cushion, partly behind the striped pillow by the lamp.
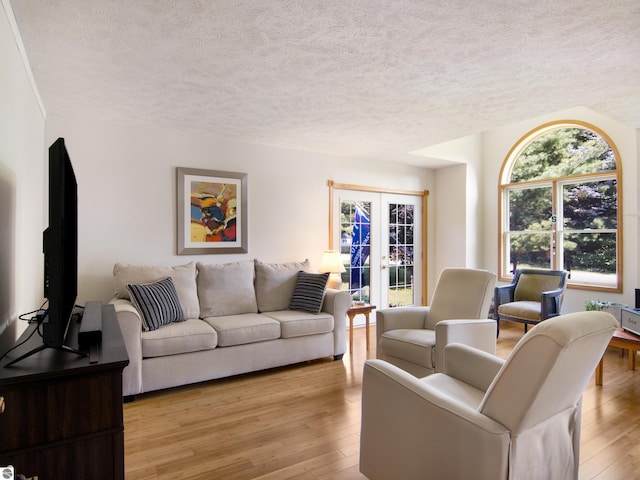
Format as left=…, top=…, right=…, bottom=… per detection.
left=255, top=259, right=310, bottom=312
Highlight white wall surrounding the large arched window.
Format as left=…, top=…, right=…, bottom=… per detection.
left=482, top=107, right=640, bottom=313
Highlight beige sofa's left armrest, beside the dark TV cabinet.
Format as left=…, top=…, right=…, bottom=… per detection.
left=109, top=298, right=142, bottom=397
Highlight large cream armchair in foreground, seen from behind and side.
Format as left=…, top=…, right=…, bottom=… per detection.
left=360, top=312, right=617, bottom=480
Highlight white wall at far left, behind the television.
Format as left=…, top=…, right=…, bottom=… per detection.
left=0, top=2, right=44, bottom=355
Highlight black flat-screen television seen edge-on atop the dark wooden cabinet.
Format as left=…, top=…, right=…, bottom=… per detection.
left=42, top=138, right=78, bottom=348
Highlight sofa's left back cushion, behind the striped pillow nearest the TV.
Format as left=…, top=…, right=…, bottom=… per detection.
left=113, top=262, right=200, bottom=318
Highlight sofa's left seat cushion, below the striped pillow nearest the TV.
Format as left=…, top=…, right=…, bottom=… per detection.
left=141, top=318, right=218, bottom=358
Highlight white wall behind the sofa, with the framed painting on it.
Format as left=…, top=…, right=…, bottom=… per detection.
left=45, top=116, right=433, bottom=302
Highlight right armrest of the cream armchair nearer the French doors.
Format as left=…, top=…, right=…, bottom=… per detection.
left=434, top=318, right=497, bottom=372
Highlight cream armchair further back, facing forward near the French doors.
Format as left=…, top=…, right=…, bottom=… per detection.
left=376, top=268, right=496, bottom=377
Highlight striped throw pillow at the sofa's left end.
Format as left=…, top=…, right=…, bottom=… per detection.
left=127, top=277, right=184, bottom=332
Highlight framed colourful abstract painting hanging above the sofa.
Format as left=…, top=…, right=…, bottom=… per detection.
left=176, top=167, right=248, bottom=255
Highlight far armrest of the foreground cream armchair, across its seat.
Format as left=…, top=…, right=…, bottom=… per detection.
left=443, top=343, right=504, bottom=392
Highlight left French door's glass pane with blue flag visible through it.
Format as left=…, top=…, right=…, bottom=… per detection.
left=340, top=200, right=371, bottom=303
